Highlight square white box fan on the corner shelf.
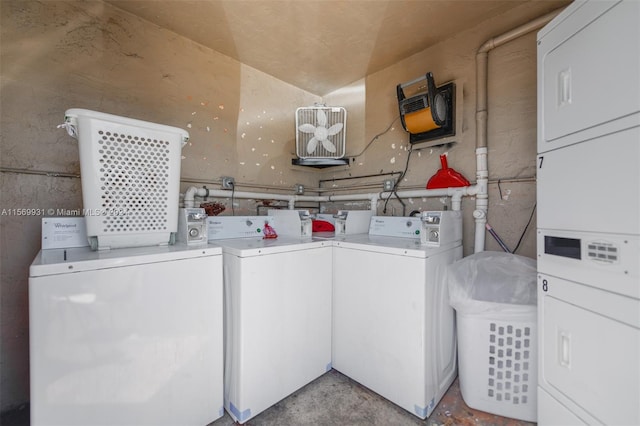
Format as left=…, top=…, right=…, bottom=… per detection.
left=296, top=105, right=347, bottom=160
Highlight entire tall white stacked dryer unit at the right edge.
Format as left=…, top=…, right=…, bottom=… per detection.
left=538, top=0, right=640, bottom=426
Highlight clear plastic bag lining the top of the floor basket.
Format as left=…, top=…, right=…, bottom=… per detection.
left=446, top=251, right=537, bottom=314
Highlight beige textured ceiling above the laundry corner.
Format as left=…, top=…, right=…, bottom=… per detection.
left=107, top=0, right=567, bottom=96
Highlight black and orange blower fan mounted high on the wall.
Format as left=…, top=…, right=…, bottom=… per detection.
left=396, top=72, right=456, bottom=144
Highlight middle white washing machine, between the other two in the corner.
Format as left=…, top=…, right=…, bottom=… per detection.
left=209, top=218, right=331, bottom=423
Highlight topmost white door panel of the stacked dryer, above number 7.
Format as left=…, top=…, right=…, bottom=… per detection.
left=538, top=0, right=640, bottom=153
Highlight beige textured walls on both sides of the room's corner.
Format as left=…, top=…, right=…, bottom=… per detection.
left=0, top=0, right=556, bottom=410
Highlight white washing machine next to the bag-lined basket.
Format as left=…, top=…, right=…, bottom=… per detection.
left=333, top=212, right=462, bottom=419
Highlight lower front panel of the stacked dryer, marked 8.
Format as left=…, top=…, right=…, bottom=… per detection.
left=538, top=274, right=640, bottom=425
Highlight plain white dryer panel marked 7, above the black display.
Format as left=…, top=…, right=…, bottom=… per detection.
left=538, top=128, right=640, bottom=235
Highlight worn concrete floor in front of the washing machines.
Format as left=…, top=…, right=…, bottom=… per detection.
left=0, top=370, right=535, bottom=426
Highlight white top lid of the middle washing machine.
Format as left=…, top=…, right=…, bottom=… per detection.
left=216, top=236, right=331, bottom=257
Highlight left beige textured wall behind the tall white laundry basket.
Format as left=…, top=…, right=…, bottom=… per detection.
left=0, top=1, right=320, bottom=410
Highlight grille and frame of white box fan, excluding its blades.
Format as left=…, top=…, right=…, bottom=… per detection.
left=296, top=107, right=347, bottom=159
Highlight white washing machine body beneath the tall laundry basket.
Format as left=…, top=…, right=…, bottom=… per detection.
left=29, top=244, right=224, bottom=426
